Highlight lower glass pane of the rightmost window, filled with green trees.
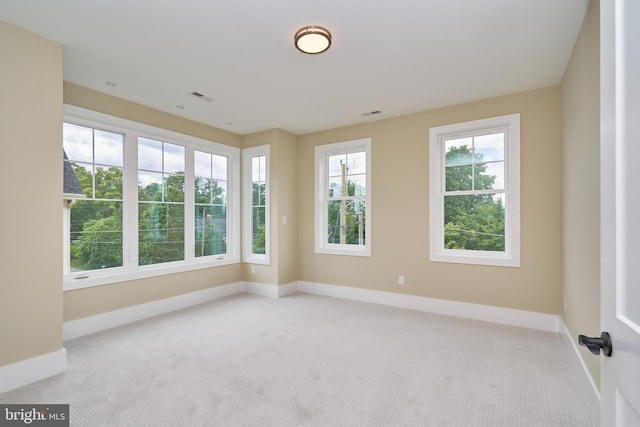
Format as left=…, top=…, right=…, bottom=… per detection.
left=444, top=194, right=505, bottom=252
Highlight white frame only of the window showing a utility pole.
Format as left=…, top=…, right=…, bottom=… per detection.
left=314, top=138, right=372, bottom=257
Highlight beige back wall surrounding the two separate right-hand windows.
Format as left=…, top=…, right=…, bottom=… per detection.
left=298, top=86, right=562, bottom=314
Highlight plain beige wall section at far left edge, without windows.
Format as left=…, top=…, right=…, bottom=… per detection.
left=0, top=21, right=62, bottom=366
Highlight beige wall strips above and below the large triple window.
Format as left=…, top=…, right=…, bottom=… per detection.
left=62, top=82, right=243, bottom=321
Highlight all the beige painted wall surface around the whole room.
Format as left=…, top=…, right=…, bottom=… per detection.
left=0, top=10, right=599, bottom=392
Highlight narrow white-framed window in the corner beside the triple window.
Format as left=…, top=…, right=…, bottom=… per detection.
left=242, top=145, right=270, bottom=264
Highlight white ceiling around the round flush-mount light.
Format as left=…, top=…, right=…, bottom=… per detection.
left=0, top=0, right=589, bottom=134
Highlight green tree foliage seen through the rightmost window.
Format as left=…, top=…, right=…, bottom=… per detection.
left=444, top=145, right=505, bottom=251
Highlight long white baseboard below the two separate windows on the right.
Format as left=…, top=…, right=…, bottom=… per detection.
left=298, top=282, right=560, bottom=332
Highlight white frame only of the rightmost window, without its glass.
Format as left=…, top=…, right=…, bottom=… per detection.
left=429, top=113, right=521, bottom=267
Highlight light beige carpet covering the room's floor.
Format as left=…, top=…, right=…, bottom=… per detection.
left=0, top=293, right=597, bottom=427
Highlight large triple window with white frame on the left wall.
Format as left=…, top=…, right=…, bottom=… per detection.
left=63, top=106, right=240, bottom=290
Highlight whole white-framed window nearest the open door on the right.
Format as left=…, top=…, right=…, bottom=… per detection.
left=429, top=114, right=520, bottom=267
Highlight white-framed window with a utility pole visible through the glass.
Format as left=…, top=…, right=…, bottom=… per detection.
left=315, top=138, right=371, bottom=256
